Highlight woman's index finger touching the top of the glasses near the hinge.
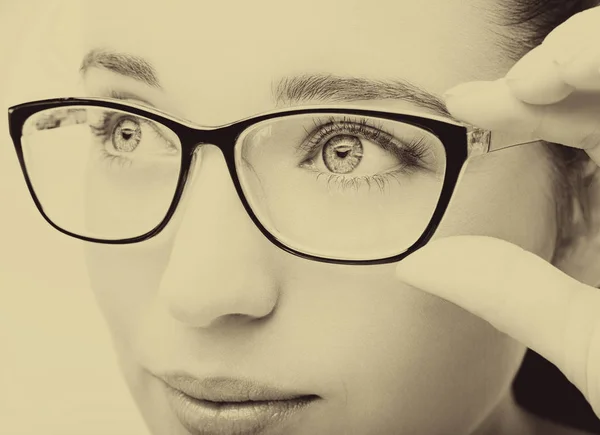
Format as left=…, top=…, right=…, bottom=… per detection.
left=446, top=79, right=600, bottom=165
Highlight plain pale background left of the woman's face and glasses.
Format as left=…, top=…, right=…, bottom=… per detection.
left=0, top=0, right=148, bottom=435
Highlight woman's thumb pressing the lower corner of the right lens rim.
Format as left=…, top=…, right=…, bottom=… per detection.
left=396, top=236, right=600, bottom=403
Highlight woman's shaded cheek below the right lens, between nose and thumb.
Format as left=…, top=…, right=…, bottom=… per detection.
left=271, top=265, right=524, bottom=434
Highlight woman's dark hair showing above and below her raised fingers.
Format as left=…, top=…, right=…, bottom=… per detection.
left=500, top=0, right=600, bottom=261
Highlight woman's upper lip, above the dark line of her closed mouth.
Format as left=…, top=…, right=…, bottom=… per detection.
left=159, top=373, right=317, bottom=403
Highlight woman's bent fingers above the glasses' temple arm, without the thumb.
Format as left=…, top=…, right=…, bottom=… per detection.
left=438, top=7, right=600, bottom=165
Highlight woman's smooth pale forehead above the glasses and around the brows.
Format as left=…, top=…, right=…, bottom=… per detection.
left=78, top=0, right=509, bottom=123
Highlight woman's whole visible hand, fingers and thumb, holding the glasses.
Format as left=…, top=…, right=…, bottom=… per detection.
left=397, top=7, right=600, bottom=416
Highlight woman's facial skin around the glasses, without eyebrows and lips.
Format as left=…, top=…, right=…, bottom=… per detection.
left=84, top=0, right=555, bottom=435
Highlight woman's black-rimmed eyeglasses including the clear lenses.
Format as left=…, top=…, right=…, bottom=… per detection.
left=9, top=98, right=530, bottom=264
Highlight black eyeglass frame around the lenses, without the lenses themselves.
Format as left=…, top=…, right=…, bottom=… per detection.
left=8, top=97, right=500, bottom=265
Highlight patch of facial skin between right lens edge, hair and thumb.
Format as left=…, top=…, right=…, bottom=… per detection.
left=434, top=144, right=557, bottom=260
